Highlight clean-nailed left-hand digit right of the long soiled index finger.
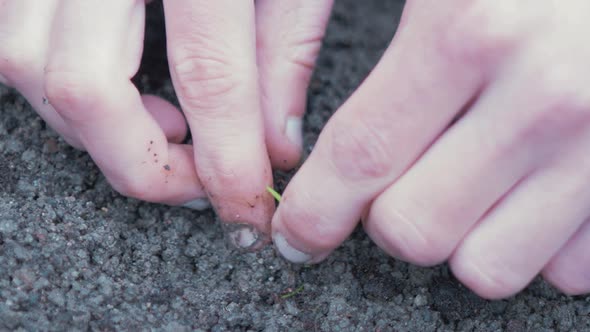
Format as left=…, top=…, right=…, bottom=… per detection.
left=256, top=0, right=333, bottom=169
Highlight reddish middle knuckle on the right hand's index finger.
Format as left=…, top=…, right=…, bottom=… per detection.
left=329, top=118, right=395, bottom=181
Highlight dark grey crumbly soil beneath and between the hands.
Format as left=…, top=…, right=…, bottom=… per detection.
left=0, top=0, right=590, bottom=331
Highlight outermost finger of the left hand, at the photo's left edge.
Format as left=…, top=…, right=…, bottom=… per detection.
left=0, top=0, right=83, bottom=149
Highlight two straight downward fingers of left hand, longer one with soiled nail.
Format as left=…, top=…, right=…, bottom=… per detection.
left=164, top=0, right=332, bottom=249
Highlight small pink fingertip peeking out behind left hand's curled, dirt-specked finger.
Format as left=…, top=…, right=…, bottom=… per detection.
left=141, top=95, right=188, bottom=143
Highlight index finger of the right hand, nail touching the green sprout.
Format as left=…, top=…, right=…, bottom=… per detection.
left=273, top=1, right=486, bottom=262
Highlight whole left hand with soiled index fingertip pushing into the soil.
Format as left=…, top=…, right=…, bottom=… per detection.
left=0, top=0, right=331, bottom=249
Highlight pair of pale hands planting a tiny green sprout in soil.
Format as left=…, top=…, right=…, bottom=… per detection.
left=0, top=0, right=590, bottom=298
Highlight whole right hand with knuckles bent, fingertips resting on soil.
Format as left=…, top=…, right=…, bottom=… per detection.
left=272, top=0, right=590, bottom=298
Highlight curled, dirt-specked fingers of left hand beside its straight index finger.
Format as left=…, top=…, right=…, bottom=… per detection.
left=0, top=0, right=205, bottom=210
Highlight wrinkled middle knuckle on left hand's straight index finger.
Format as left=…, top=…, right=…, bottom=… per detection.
left=171, top=46, right=245, bottom=111
